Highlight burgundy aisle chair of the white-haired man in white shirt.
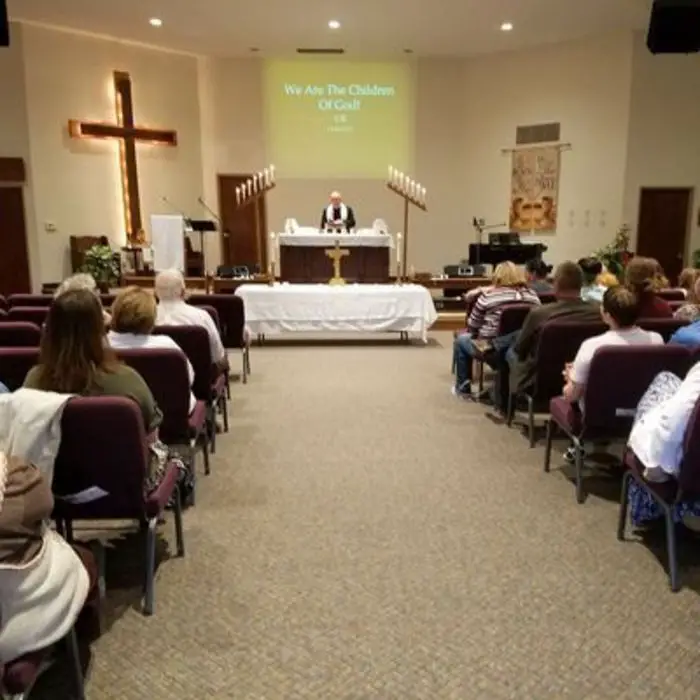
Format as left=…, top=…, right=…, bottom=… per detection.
left=153, top=326, right=228, bottom=446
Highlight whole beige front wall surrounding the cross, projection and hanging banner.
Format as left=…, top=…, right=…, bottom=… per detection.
left=5, top=21, right=700, bottom=286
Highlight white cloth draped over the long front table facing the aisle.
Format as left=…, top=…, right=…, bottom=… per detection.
left=236, top=283, right=437, bottom=341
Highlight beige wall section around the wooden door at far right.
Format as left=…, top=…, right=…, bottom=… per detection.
left=625, top=35, right=700, bottom=260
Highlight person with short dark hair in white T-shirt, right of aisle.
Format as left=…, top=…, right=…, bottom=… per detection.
left=564, top=287, right=664, bottom=403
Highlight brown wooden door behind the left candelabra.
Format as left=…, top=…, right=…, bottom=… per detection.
left=219, top=174, right=268, bottom=272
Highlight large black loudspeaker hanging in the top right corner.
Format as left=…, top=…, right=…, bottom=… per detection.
left=647, top=0, right=700, bottom=53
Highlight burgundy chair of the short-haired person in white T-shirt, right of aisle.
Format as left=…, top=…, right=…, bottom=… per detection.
left=544, top=345, right=690, bottom=503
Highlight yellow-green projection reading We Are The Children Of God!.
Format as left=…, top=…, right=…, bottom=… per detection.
left=264, top=58, right=414, bottom=179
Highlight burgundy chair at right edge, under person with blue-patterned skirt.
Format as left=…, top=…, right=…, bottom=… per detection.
left=617, top=394, right=700, bottom=593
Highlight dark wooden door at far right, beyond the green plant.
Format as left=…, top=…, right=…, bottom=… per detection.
left=637, top=187, right=692, bottom=284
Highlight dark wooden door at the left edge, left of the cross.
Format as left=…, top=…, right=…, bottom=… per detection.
left=0, top=185, right=31, bottom=296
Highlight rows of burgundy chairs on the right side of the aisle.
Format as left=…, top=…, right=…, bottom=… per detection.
left=460, top=304, right=700, bottom=591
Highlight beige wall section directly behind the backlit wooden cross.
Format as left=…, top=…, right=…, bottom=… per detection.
left=17, top=26, right=202, bottom=281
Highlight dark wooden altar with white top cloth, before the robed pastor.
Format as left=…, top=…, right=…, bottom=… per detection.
left=277, top=229, right=393, bottom=283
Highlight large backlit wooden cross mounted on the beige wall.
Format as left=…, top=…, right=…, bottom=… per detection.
left=68, top=71, right=177, bottom=245
